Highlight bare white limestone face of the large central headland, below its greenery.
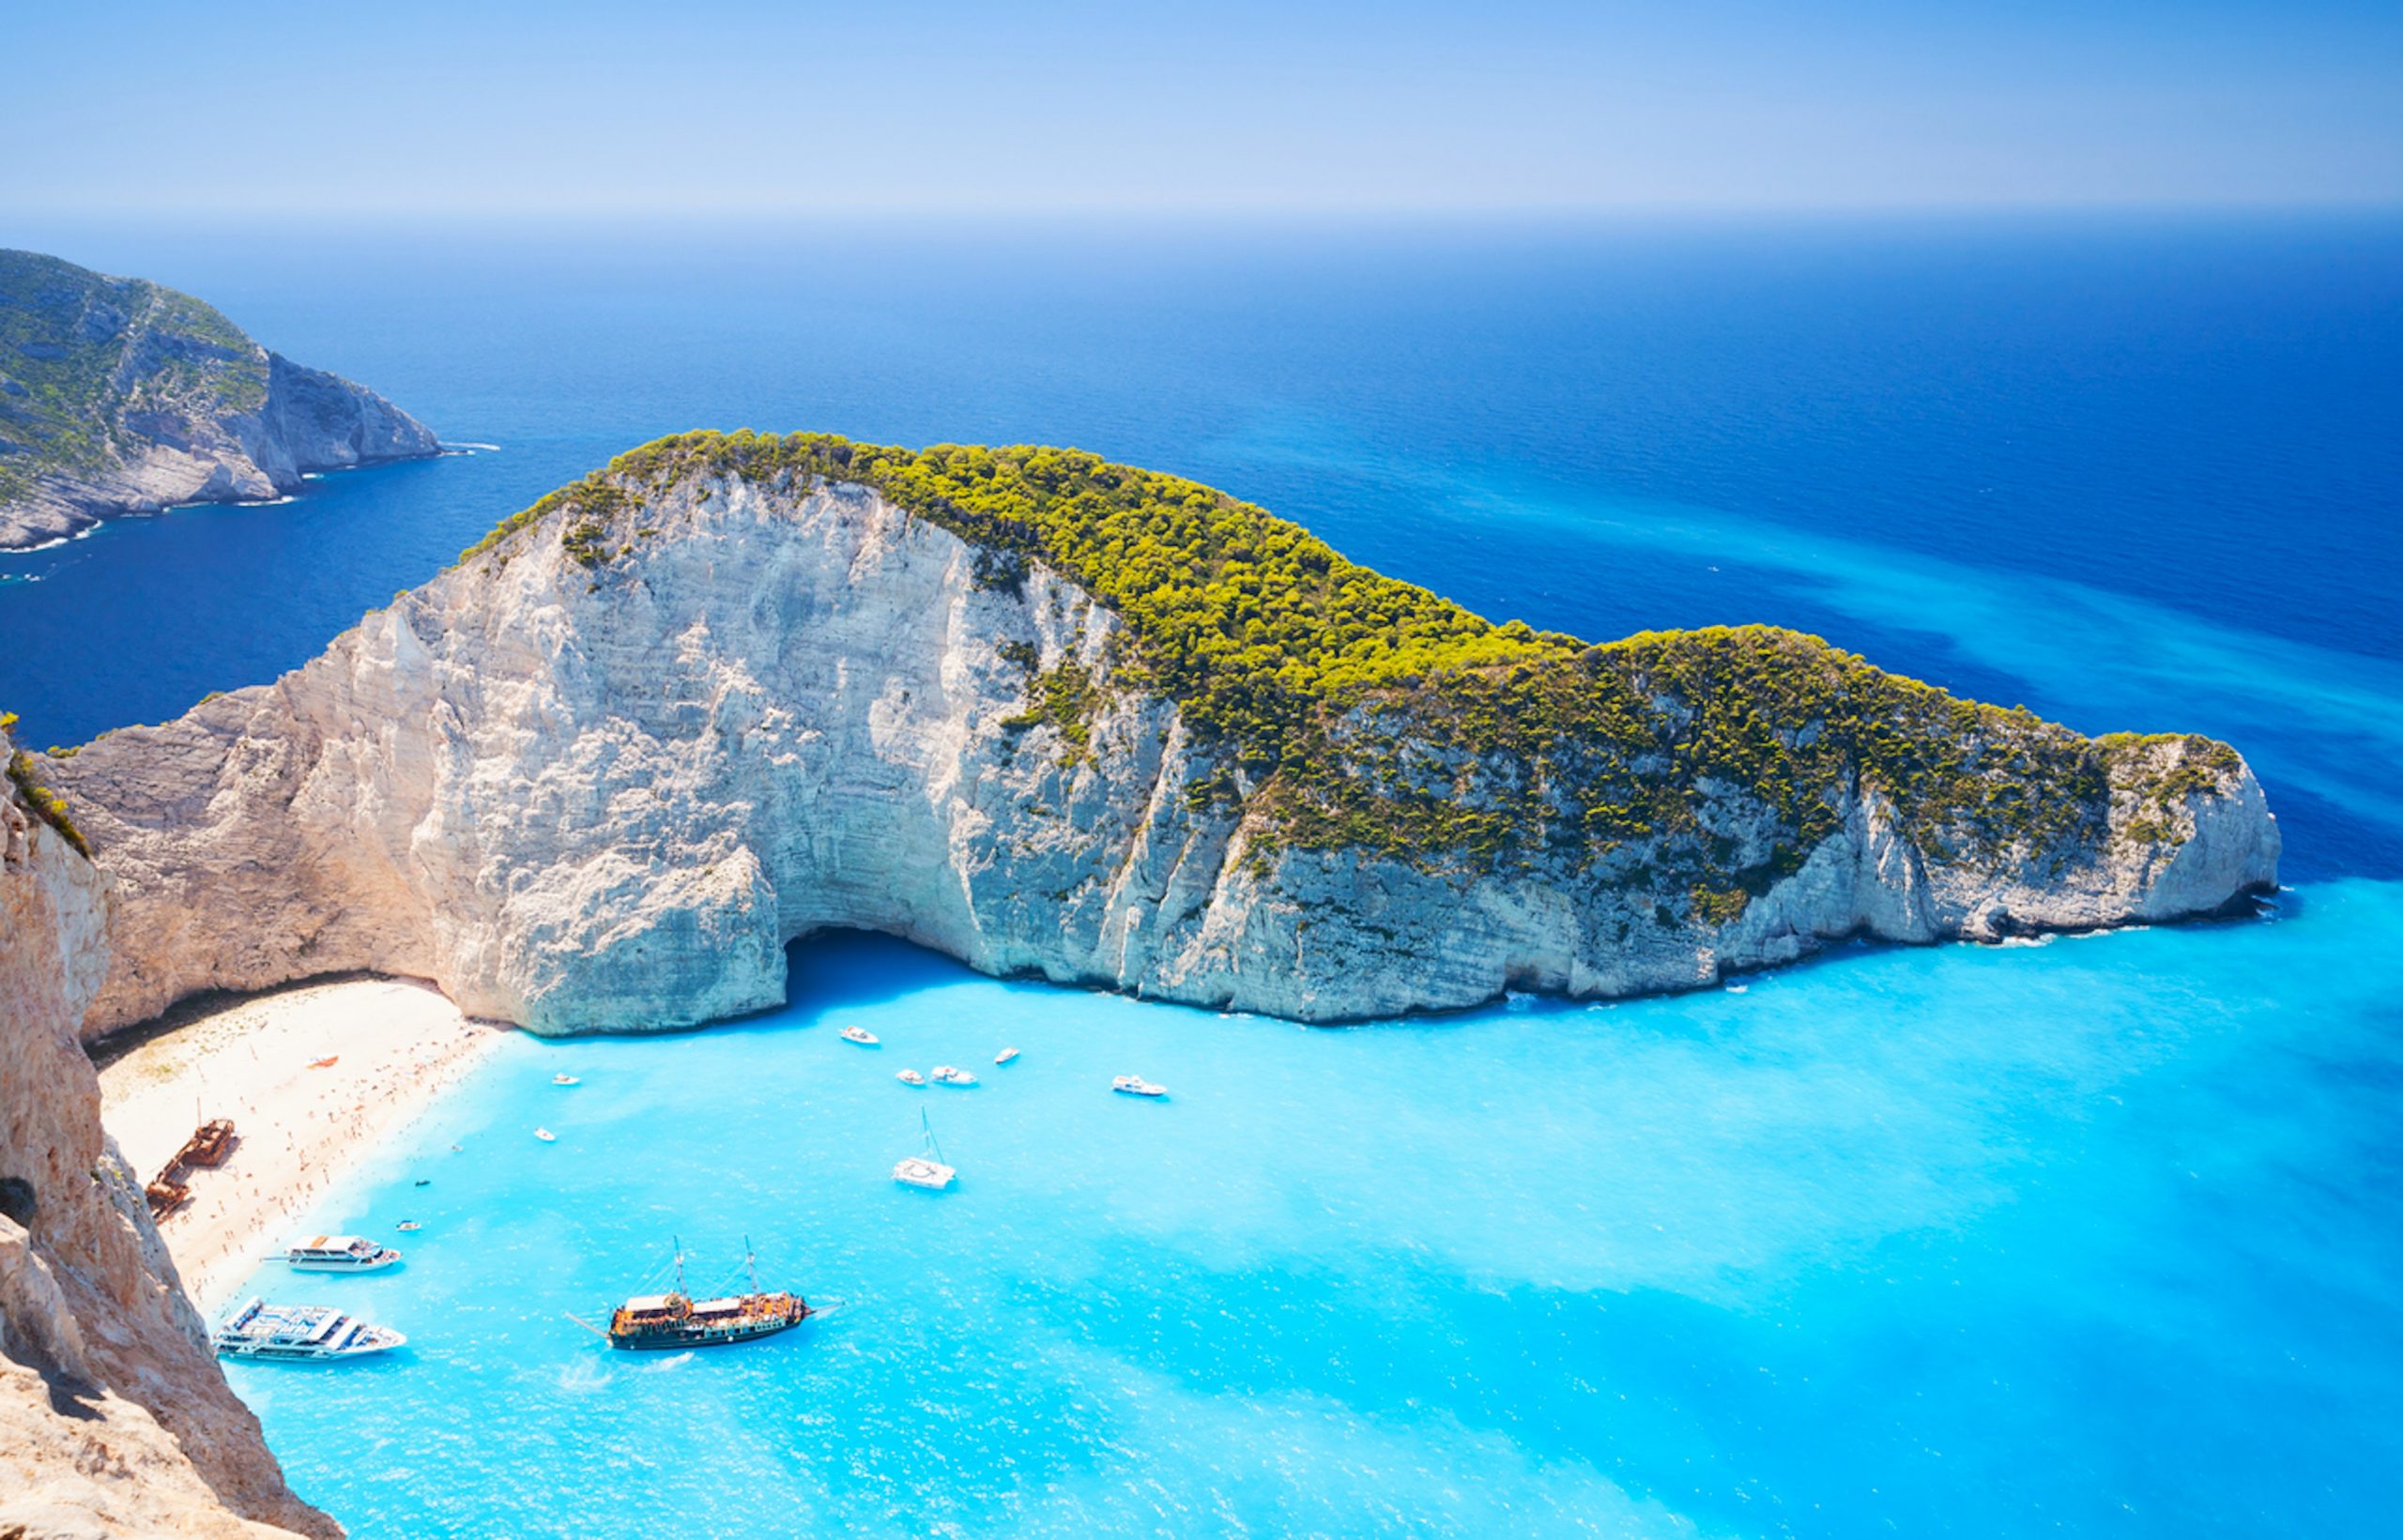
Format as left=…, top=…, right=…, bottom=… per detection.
left=46, top=478, right=2278, bottom=1033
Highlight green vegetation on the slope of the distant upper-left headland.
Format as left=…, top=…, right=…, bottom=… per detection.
left=0, top=250, right=267, bottom=502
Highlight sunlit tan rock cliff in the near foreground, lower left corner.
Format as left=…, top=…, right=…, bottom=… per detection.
left=0, top=718, right=342, bottom=1540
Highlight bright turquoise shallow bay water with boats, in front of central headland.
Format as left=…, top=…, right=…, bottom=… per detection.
left=231, top=882, right=2403, bottom=1537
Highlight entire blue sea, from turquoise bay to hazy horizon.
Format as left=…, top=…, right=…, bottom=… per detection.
left=0, top=219, right=2403, bottom=1540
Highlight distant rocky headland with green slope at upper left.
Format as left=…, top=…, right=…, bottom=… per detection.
left=0, top=250, right=439, bottom=550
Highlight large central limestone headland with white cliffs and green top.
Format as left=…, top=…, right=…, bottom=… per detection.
left=46, top=435, right=2278, bottom=1033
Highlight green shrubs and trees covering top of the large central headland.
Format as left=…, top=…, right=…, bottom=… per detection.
left=462, top=433, right=2235, bottom=922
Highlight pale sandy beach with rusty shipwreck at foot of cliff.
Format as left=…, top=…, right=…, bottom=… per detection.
left=101, top=978, right=510, bottom=1317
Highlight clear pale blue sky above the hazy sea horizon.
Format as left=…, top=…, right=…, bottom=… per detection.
left=0, top=0, right=2403, bottom=216
